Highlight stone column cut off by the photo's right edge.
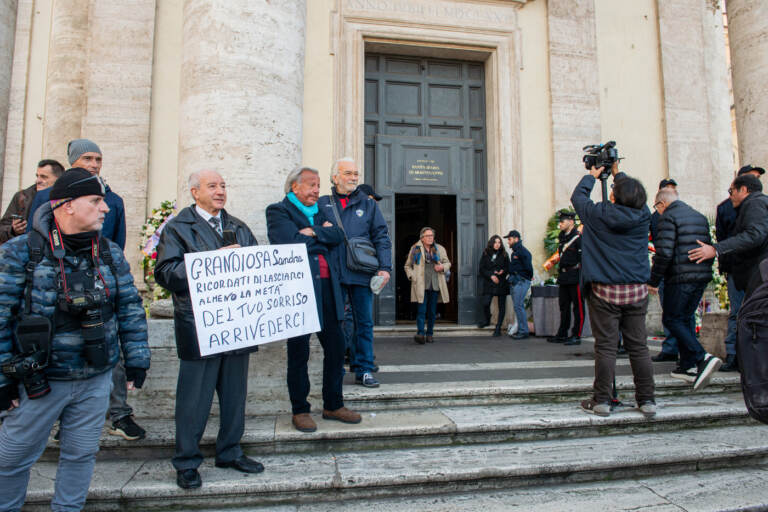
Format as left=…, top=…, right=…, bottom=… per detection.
left=727, top=0, right=768, bottom=167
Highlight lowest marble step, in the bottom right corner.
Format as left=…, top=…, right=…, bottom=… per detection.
left=189, top=465, right=768, bottom=512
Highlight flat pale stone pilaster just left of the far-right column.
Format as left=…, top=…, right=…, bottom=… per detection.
left=649, top=0, right=734, bottom=215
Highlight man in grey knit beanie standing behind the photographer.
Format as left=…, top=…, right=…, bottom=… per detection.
left=27, top=139, right=146, bottom=441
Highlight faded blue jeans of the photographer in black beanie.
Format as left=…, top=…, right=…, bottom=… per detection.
left=0, top=371, right=112, bottom=511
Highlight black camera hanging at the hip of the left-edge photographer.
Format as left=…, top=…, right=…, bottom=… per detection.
left=0, top=315, right=51, bottom=400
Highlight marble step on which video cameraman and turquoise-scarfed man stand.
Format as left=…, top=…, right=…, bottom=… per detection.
left=44, top=393, right=751, bottom=460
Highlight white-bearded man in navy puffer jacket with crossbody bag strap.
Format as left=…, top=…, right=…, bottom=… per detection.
left=317, top=158, right=392, bottom=388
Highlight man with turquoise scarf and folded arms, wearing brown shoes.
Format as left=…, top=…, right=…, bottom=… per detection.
left=267, top=167, right=361, bottom=432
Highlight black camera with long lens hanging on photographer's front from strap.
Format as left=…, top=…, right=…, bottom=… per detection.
left=59, top=270, right=109, bottom=366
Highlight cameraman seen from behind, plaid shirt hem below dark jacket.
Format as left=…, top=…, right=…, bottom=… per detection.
left=571, top=158, right=656, bottom=418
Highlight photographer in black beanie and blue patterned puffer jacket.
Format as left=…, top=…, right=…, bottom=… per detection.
left=0, top=168, right=149, bottom=510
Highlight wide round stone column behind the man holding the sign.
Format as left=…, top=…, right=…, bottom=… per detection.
left=177, top=0, right=306, bottom=242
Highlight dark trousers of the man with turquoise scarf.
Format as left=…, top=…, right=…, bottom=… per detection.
left=285, top=279, right=344, bottom=414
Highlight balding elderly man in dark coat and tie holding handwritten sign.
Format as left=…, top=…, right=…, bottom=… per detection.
left=155, top=170, right=264, bottom=489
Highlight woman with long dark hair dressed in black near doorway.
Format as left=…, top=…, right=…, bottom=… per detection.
left=478, top=235, right=509, bottom=336
